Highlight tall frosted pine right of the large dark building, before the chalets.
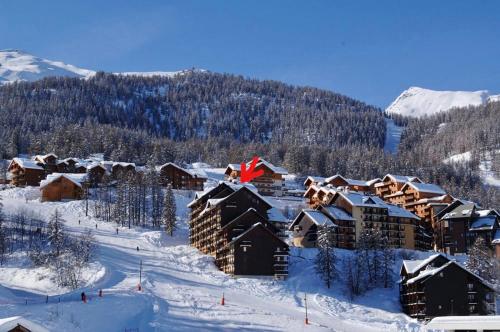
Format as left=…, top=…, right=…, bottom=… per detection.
left=316, top=226, right=337, bottom=288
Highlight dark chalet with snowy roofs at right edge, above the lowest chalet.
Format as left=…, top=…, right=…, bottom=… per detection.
left=434, top=200, right=500, bottom=255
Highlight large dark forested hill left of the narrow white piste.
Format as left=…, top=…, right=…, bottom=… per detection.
left=0, top=71, right=385, bottom=163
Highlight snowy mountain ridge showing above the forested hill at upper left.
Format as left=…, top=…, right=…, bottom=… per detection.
left=0, top=49, right=199, bottom=84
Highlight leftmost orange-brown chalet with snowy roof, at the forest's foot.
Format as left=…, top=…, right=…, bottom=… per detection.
left=7, top=158, right=46, bottom=187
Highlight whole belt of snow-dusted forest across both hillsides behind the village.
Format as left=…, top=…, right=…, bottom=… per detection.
left=0, top=71, right=500, bottom=207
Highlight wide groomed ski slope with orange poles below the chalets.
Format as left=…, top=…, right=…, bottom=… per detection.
left=0, top=183, right=422, bottom=332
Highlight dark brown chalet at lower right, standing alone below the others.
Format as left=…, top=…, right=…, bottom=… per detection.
left=399, top=254, right=496, bottom=319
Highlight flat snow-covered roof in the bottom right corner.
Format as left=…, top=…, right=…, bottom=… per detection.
left=425, top=315, right=500, bottom=331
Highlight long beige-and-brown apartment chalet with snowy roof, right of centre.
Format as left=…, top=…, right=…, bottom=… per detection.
left=328, top=191, right=423, bottom=249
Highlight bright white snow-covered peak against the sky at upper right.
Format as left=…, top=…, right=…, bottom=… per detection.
left=385, top=87, right=500, bottom=117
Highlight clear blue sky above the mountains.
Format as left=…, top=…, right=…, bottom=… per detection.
left=0, top=0, right=500, bottom=107
